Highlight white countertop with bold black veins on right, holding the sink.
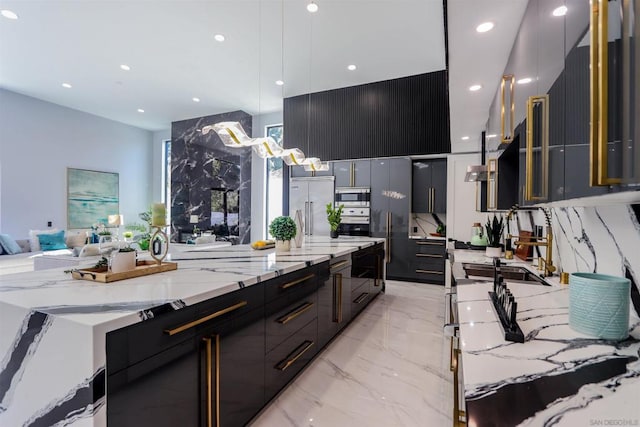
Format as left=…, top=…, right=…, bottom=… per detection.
left=453, top=250, right=640, bottom=427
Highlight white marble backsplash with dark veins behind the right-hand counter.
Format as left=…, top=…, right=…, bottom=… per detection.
left=518, top=204, right=640, bottom=320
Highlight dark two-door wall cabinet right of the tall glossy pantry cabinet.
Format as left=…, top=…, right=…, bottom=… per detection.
left=411, top=159, right=447, bottom=213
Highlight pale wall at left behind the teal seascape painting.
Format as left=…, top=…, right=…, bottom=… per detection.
left=0, top=89, right=153, bottom=239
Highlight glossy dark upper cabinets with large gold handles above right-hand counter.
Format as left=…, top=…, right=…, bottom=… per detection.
left=487, top=0, right=640, bottom=209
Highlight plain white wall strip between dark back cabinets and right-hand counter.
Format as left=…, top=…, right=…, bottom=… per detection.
left=447, top=153, right=487, bottom=242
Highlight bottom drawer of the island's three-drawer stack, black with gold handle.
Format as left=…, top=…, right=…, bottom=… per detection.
left=265, top=319, right=319, bottom=401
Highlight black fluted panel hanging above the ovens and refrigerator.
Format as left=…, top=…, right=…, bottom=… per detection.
left=284, top=70, right=451, bottom=160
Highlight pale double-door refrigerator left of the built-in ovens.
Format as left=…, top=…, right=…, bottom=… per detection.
left=289, top=176, right=334, bottom=237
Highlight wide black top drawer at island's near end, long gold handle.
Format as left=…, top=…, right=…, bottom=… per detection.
left=106, top=284, right=264, bottom=375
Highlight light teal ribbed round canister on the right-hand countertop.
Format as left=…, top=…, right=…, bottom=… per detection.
left=569, top=273, right=631, bottom=340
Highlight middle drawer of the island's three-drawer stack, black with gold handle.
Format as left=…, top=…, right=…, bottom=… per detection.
left=266, top=290, right=318, bottom=352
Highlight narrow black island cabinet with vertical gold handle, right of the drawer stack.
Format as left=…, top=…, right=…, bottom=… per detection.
left=318, top=256, right=351, bottom=348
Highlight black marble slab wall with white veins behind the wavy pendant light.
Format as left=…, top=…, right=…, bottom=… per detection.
left=171, top=111, right=252, bottom=243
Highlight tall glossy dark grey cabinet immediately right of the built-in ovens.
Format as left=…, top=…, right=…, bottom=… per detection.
left=371, top=158, right=412, bottom=280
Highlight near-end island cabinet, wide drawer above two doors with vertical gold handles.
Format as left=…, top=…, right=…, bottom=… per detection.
left=106, top=285, right=265, bottom=427
